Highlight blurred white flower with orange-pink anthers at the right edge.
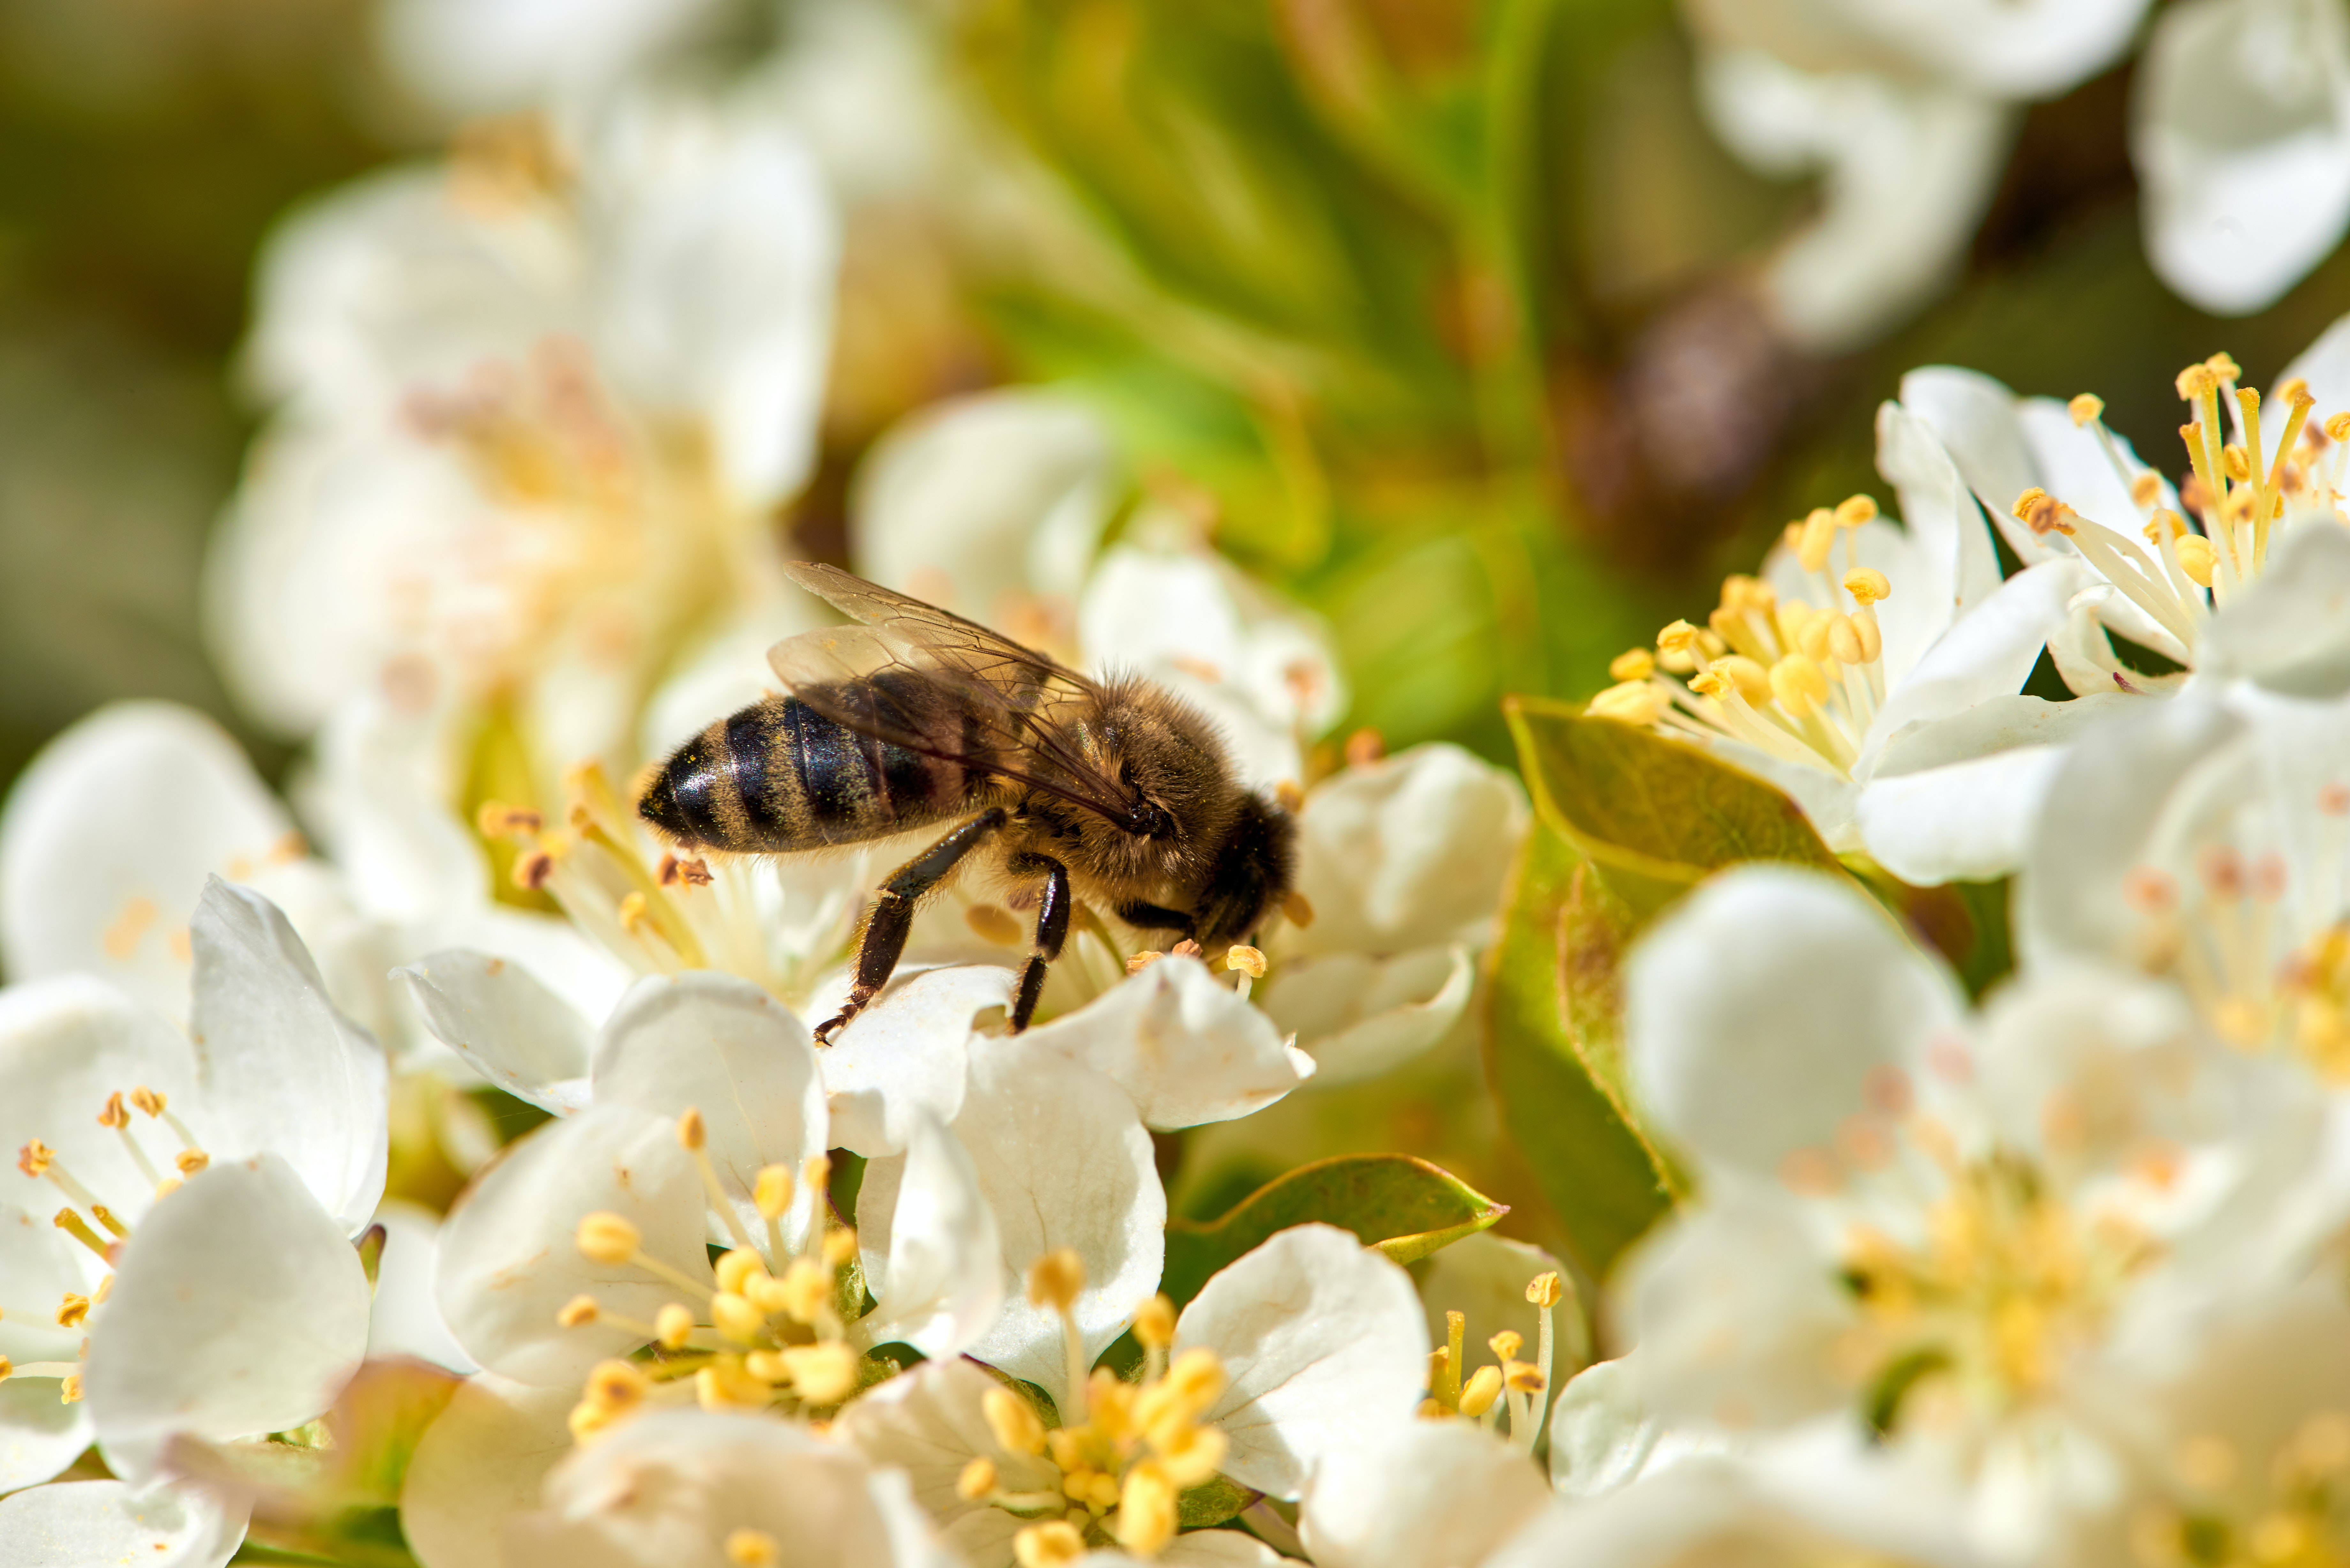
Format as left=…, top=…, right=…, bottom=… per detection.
left=2016, top=689, right=2350, bottom=1084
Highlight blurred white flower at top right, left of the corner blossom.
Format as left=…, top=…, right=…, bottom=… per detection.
left=1683, top=0, right=2146, bottom=350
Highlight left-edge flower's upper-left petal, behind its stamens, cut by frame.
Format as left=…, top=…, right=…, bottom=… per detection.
left=0, top=976, right=202, bottom=1232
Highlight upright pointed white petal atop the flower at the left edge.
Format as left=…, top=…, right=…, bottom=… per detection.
left=188, top=879, right=390, bottom=1234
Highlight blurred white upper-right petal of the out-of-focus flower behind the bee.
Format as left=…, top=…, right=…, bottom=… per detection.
left=583, top=101, right=839, bottom=508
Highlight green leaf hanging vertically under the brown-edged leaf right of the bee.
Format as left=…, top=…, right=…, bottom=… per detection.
left=1485, top=820, right=1678, bottom=1279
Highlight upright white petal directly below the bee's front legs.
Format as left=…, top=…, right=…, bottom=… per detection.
left=954, top=1037, right=1168, bottom=1411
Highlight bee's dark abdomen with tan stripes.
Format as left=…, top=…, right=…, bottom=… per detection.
left=637, top=677, right=973, bottom=851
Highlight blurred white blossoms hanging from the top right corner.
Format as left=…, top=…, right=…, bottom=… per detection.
left=1680, top=0, right=2350, bottom=353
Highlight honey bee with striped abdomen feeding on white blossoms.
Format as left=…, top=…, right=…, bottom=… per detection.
left=637, top=562, right=1297, bottom=1041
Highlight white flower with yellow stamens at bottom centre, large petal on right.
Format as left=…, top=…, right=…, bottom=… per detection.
left=839, top=1225, right=1419, bottom=1568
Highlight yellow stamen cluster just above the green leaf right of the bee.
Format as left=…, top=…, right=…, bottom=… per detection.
left=1588, top=496, right=1892, bottom=778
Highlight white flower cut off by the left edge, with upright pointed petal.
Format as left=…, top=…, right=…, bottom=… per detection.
left=0, top=882, right=385, bottom=1507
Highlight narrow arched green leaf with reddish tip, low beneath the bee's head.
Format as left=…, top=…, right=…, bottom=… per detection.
left=1161, top=1154, right=1509, bottom=1307
